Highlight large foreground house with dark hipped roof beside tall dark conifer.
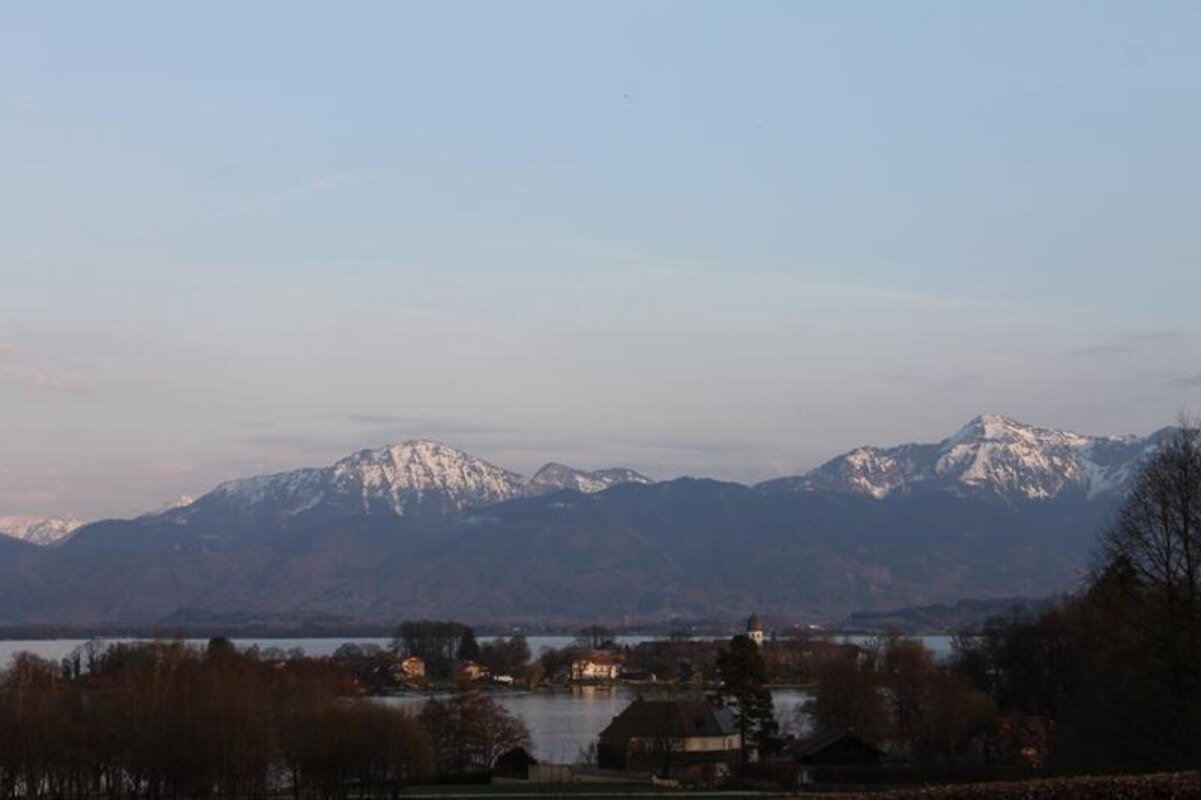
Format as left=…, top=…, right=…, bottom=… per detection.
left=597, top=697, right=742, bottom=777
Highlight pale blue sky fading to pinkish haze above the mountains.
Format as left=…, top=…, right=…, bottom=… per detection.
left=0, top=0, right=1201, bottom=519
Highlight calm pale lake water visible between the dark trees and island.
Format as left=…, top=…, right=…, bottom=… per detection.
left=0, top=635, right=951, bottom=763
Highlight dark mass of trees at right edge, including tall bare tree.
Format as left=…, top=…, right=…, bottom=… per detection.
left=956, top=420, right=1201, bottom=772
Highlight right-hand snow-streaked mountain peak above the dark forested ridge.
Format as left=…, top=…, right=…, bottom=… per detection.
left=760, top=414, right=1161, bottom=500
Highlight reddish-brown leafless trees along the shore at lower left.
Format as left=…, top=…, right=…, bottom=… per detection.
left=0, top=640, right=528, bottom=800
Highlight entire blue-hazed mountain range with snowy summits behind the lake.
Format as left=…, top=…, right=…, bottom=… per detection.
left=0, top=416, right=1165, bottom=622
